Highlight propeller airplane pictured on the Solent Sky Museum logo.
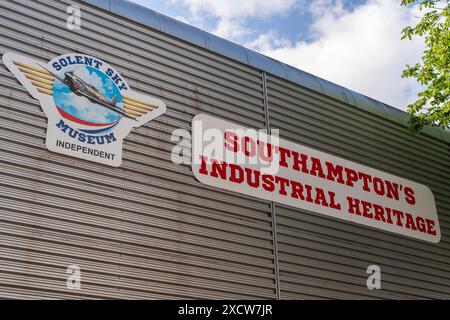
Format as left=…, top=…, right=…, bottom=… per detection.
left=39, top=64, right=136, bottom=121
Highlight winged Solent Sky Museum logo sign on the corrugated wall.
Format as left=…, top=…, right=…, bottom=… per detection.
left=2, top=52, right=166, bottom=167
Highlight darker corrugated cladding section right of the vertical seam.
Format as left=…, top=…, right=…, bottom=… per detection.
left=268, top=77, right=450, bottom=299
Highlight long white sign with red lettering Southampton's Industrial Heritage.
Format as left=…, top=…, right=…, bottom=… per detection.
left=192, top=114, right=441, bottom=243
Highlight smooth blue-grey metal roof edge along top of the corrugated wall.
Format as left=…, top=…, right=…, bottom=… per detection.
left=81, top=0, right=450, bottom=143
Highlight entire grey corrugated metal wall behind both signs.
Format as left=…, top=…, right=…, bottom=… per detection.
left=0, top=0, right=450, bottom=299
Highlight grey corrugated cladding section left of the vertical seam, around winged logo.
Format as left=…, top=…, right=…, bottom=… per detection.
left=0, top=0, right=276, bottom=299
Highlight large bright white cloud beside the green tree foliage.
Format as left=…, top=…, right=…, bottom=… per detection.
left=253, top=0, right=424, bottom=109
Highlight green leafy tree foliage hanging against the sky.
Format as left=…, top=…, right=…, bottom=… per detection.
left=400, top=0, right=450, bottom=133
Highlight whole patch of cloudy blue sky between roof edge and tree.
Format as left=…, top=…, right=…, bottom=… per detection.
left=129, top=0, right=424, bottom=110
